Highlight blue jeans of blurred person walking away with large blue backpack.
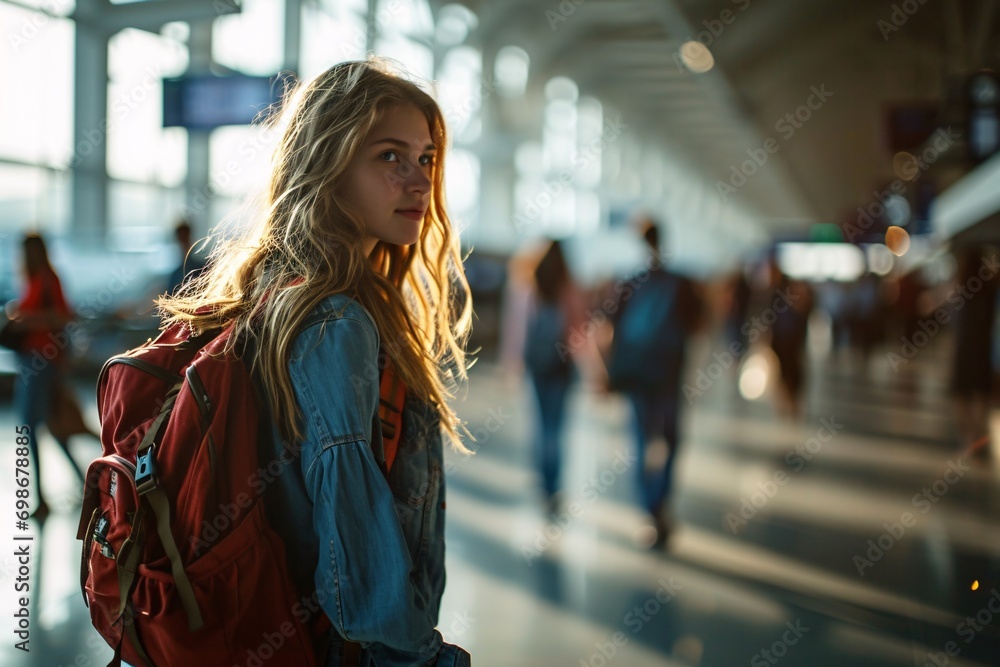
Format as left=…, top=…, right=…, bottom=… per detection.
left=628, top=389, right=680, bottom=515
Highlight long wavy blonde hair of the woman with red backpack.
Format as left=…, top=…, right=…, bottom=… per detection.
left=157, top=58, right=472, bottom=451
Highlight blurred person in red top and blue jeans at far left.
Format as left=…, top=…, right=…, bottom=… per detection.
left=9, top=234, right=88, bottom=520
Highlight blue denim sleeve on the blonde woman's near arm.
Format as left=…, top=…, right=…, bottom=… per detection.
left=290, top=318, right=442, bottom=666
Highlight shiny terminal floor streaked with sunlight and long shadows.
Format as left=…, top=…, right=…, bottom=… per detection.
left=0, top=336, right=1000, bottom=667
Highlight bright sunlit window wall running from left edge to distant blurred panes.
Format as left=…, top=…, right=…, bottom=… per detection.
left=0, top=0, right=636, bottom=256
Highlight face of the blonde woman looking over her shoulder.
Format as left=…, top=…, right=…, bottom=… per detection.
left=340, top=104, right=435, bottom=254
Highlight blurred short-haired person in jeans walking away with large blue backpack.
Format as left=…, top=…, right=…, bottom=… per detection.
left=608, top=220, right=703, bottom=548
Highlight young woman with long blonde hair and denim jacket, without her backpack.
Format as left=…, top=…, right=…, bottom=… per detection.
left=160, top=59, right=471, bottom=667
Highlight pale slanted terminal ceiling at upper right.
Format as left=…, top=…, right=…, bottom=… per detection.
left=432, top=0, right=1000, bottom=237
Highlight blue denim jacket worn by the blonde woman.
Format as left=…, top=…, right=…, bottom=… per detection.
left=269, top=295, right=470, bottom=667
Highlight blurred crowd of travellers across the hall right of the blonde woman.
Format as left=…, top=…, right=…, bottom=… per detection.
left=499, top=218, right=998, bottom=547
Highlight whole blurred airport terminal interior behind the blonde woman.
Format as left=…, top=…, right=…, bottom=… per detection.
left=0, top=0, right=1000, bottom=667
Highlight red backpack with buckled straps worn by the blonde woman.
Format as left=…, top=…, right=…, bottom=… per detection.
left=77, top=325, right=405, bottom=667
